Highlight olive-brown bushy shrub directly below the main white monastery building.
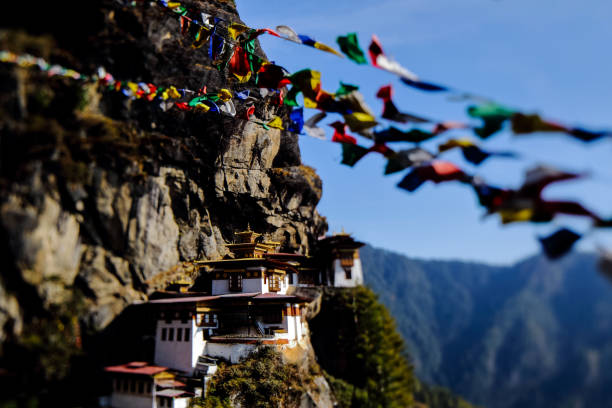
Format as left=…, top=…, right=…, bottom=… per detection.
left=192, top=347, right=304, bottom=408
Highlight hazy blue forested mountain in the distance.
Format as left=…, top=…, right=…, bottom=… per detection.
left=361, top=246, right=612, bottom=408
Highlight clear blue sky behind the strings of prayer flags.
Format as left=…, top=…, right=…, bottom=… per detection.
left=236, top=0, right=612, bottom=264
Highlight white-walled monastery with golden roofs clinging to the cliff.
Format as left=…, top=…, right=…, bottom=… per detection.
left=105, top=228, right=364, bottom=408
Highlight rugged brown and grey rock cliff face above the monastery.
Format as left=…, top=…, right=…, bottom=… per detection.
left=0, top=0, right=326, bottom=376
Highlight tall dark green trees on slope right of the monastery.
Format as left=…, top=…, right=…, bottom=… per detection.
left=311, top=287, right=415, bottom=408
